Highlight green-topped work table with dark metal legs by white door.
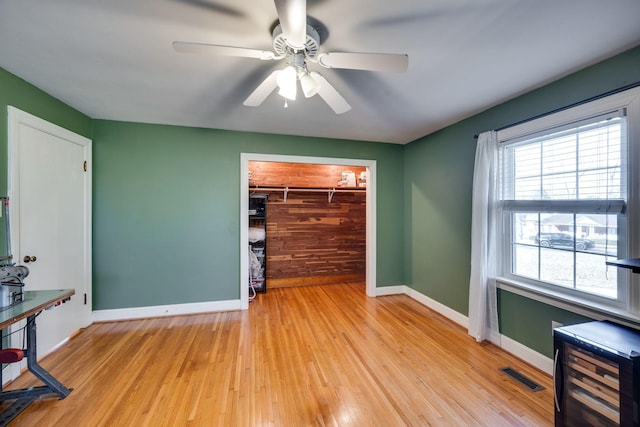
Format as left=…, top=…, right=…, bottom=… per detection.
left=0, top=289, right=75, bottom=426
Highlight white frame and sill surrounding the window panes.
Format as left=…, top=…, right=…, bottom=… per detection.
left=497, top=87, right=640, bottom=323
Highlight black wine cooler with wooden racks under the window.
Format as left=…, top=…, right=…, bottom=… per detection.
left=553, top=321, right=640, bottom=426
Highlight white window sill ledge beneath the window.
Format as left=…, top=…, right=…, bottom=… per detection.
left=496, top=277, right=640, bottom=329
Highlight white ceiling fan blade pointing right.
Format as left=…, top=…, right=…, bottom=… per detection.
left=318, top=52, right=409, bottom=73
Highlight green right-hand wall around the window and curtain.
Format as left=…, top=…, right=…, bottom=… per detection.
left=404, top=47, right=640, bottom=356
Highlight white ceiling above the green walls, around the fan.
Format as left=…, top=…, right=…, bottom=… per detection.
left=0, top=0, right=640, bottom=144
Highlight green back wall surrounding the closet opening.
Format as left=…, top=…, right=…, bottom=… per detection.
left=93, top=120, right=404, bottom=310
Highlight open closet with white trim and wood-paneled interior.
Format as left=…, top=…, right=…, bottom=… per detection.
left=240, top=153, right=375, bottom=309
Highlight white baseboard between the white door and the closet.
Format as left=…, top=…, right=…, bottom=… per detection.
left=92, top=300, right=240, bottom=322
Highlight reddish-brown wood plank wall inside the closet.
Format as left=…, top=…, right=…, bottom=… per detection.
left=249, top=161, right=366, bottom=287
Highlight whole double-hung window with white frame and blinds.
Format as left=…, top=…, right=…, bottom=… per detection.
left=498, top=90, right=640, bottom=310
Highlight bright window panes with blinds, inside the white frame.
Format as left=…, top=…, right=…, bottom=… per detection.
left=500, top=112, right=626, bottom=299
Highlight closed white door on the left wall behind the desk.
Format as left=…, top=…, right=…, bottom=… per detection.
left=9, top=107, right=91, bottom=378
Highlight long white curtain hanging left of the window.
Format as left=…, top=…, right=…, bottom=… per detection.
left=469, top=131, right=500, bottom=345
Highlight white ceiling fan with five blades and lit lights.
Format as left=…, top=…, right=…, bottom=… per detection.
left=173, top=0, right=409, bottom=114
